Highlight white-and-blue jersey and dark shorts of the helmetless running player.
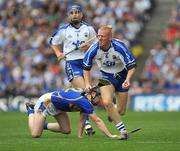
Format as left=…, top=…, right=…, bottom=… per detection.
left=83, top=39, right=136, bottom=92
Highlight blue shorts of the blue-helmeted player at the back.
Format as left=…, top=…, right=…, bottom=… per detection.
left=65, top=59, right=83, bottom=82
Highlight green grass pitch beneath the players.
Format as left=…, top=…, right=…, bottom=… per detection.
left=0, top=109, right=180, bottom=151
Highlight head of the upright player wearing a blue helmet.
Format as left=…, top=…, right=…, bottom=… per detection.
left=68, top=4, right=83, bottom=25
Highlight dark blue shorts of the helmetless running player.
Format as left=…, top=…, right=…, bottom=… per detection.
left=101, top=69, right=129, bottom=92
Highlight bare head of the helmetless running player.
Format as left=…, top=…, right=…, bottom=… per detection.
left=98, top=26, right=112, bottom=50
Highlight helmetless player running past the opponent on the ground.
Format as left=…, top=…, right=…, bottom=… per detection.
left=83, top=26, right=136, bottom=137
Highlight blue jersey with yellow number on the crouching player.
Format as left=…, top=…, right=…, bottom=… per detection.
left=51, top=88, right=94, bottom=114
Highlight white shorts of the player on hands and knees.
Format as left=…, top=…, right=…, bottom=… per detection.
left=34, top=93, right=63, bottom=117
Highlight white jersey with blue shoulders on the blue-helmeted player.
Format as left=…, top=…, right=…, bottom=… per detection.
left=50, top=22, right=96, bottom=60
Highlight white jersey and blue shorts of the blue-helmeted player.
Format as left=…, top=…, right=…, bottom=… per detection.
left=50, top=22, right=96, bottom=82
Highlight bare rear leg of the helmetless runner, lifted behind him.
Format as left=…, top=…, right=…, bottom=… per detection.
left=116, top=92, right=128, bottom=115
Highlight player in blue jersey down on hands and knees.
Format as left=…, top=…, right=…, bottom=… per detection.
left=26, top=88, right=118, bottom=139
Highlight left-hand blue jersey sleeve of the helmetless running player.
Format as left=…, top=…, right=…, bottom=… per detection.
left=83, top=43, right=98, bottom=70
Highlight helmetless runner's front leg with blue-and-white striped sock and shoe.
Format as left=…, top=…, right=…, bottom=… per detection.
left=101, top=86, right=127, bottom=139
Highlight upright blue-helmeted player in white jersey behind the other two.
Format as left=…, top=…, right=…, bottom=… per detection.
left=50, top=4, right=96, bottom=135
